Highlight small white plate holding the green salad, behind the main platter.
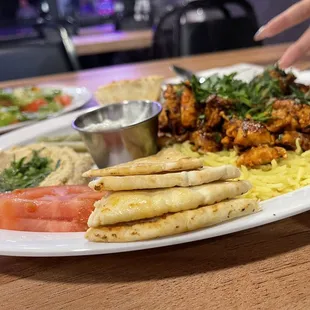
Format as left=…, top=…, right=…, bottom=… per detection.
left=0, top=84, right=92, bottom=134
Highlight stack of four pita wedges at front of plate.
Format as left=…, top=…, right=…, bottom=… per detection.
left=84, top=149, right=259, bottom=242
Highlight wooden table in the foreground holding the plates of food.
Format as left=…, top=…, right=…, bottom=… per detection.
left=0, top=45, right=310, bottom=310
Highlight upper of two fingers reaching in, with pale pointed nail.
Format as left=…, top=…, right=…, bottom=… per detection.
left=254, top=0, right=310, bottom=41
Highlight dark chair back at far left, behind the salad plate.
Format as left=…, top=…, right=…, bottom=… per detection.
left=0, top=26, right=79, bottom=81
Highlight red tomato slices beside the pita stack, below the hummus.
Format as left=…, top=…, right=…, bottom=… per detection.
left=0, top=185, right=106, bottom=232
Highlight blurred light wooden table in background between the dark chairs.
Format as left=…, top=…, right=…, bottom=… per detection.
left=72, top=28, right=153, bottom=56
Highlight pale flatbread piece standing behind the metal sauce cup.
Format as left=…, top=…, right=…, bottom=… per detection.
left=95, top=76, right=163, bottom=105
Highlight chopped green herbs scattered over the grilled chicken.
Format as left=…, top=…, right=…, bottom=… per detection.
left=191, top=65, right=310, bottom=122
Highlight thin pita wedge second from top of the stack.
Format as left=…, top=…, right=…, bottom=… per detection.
left=89, top=165, right=240, bottom=192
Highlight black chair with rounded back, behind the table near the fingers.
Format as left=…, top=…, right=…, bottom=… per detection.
left=154, top=0, right=261, bottom=57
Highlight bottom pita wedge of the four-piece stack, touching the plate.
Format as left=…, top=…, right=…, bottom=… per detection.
left=85, top=199, right=259, bottom=242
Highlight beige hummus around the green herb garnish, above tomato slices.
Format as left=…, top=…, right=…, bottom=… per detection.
left=0, top=143, right=94, bottom=186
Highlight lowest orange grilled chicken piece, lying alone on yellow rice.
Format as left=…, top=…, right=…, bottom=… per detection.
left=237, top=145, right=287, bottom=168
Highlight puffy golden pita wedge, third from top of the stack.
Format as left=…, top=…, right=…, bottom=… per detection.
left=88, top=181, right=251, bottom=227
